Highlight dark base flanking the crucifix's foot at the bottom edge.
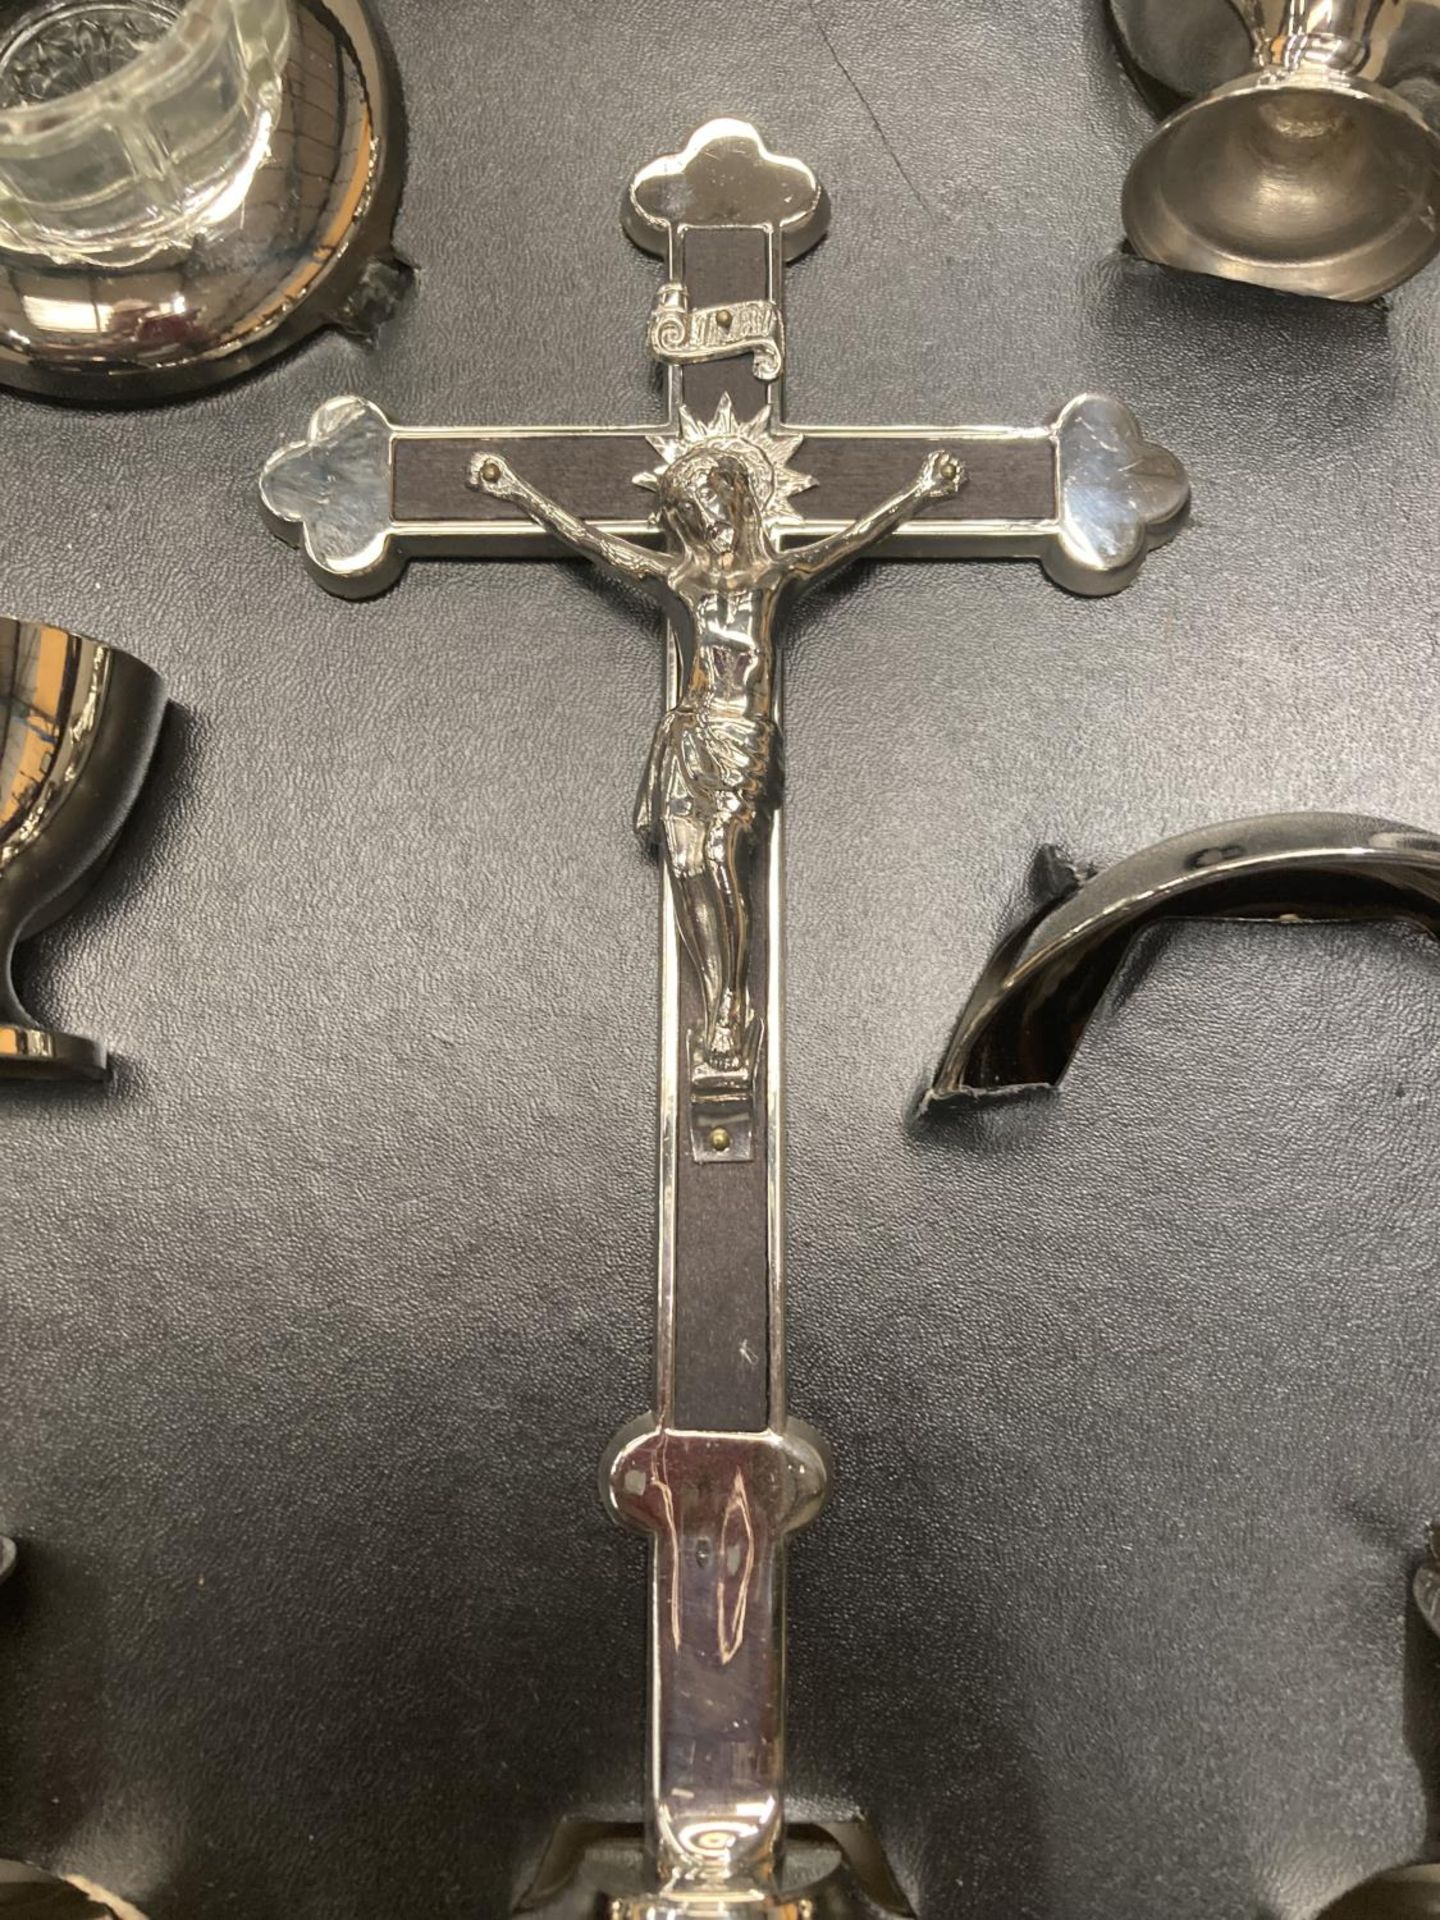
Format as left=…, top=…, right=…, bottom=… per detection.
left=515, top=1820, right=914, bottom=1920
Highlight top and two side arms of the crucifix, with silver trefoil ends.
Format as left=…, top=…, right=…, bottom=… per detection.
left=261, top=121, right=1190, bottom=599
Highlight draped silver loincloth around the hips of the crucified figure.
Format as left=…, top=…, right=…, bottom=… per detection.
left=636, top=705, right=783, bottom=847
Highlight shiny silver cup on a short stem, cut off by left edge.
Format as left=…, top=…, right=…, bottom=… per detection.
left=0, top=618, right=165, bottom=1083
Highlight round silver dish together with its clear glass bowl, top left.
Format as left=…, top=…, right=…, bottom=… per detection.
left=0, top=0, right=405, bottom=405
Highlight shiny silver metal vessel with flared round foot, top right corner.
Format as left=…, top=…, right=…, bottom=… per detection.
left=1108, top=0, right=1440, bottom=300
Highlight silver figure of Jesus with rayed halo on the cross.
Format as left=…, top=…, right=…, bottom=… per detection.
left=470, top=397, right=966, bottom=1096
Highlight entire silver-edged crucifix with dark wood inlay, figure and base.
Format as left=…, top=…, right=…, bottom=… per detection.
left=261, top=119, right=1188, bottom=1920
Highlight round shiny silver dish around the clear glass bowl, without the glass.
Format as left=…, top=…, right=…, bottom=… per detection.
left=0, top=0, right=409, bottom=405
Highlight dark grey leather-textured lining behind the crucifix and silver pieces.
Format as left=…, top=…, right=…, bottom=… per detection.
left=0, top=0, right=1440, bottom=1920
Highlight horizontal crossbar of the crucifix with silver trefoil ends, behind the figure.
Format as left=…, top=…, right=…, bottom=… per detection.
left=263, top=394, right=1190, bottom=599
